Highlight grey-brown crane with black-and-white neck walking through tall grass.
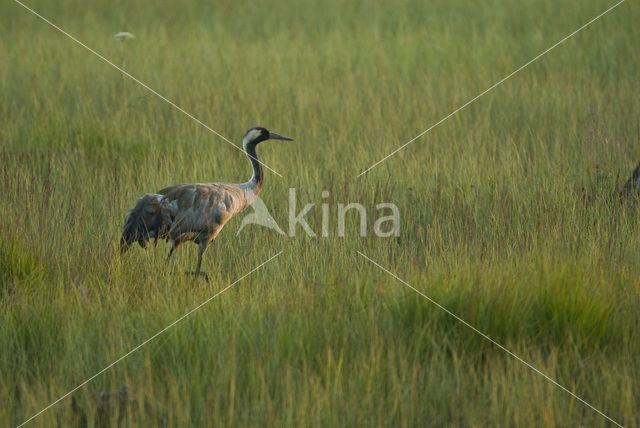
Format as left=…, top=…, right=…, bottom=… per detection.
left=120, top=127, right=293, bottom=277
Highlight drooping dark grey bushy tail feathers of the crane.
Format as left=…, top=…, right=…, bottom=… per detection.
left=120, top=193, right=171, bottom=254
